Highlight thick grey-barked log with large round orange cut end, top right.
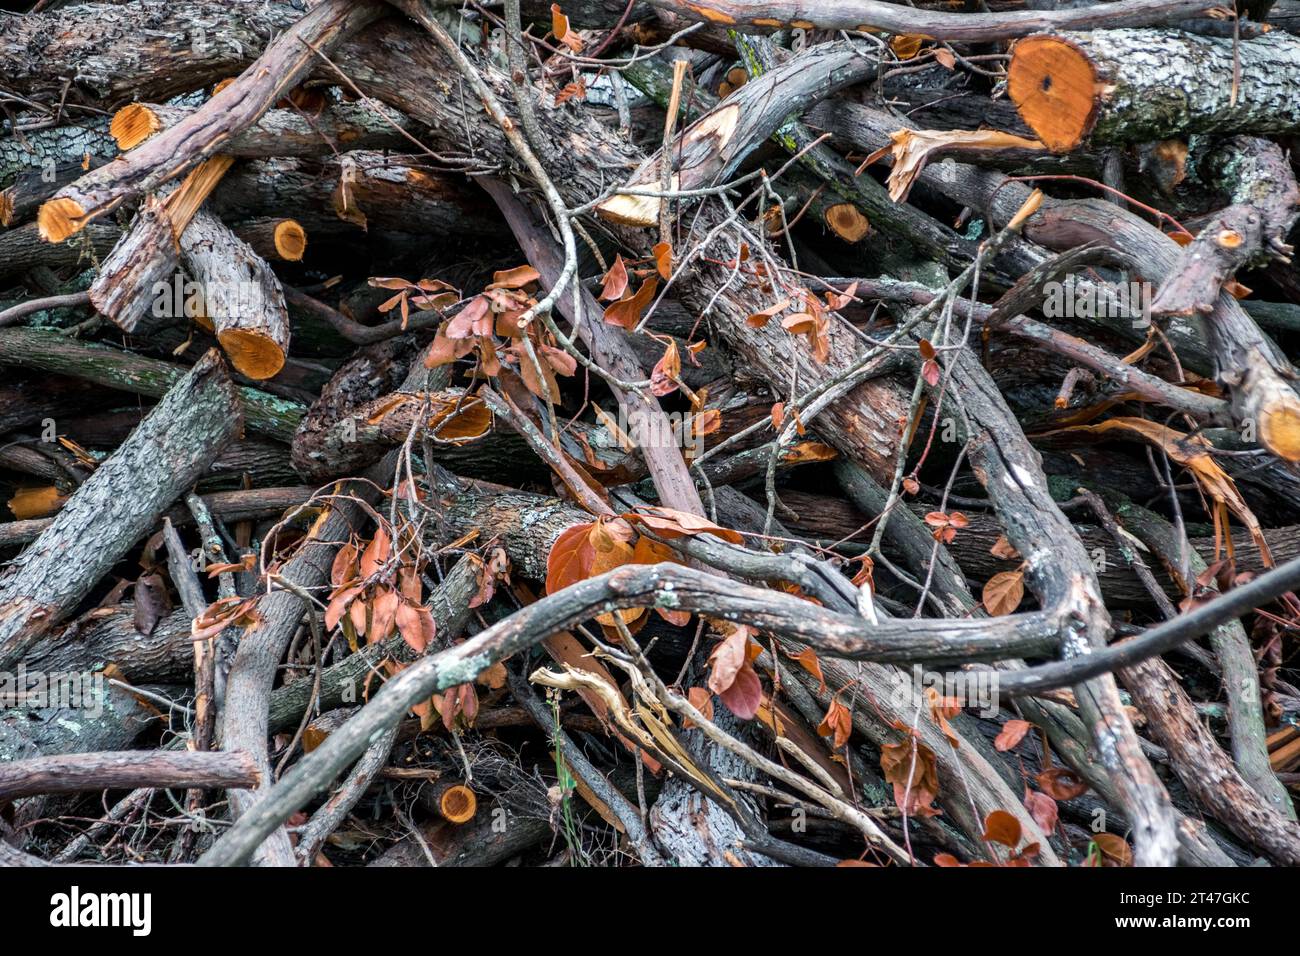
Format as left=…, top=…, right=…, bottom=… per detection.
left=1006, top=29, right=1300, bottom=152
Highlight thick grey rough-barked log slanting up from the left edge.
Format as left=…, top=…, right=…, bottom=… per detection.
left=0, top=352, right=243, bottom=666
